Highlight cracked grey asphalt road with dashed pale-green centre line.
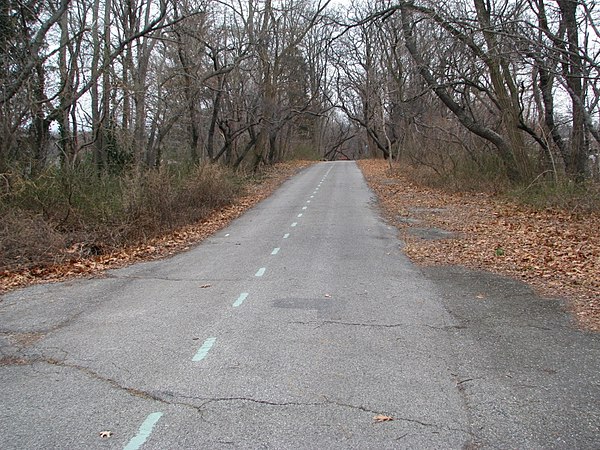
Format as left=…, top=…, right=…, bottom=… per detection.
left=0, top=162, right=600, bottom=450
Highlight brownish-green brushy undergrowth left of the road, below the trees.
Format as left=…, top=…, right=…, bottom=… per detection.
left=0, top=165, right=243, bottom=269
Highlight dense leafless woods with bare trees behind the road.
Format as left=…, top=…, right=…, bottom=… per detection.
left=0, top=0, right=600, bottom=268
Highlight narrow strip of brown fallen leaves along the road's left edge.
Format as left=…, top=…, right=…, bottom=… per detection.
left=0, top=161, right=314, bottom=294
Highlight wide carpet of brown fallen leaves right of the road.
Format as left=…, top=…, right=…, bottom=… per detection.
left=360, top=161, right=600, bottom=331
